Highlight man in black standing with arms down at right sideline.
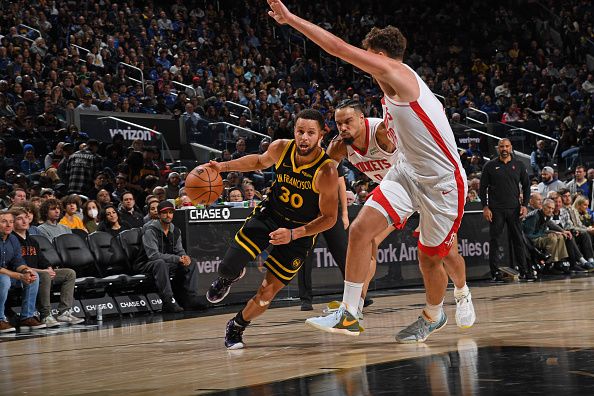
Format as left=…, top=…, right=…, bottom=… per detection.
left=480, top=139, right=534, bottom=280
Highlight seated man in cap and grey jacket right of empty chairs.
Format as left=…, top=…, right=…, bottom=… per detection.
left=133, top=201, right=198, bottom=312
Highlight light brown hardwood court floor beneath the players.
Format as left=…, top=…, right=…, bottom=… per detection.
left=0, top=276, right=594, bottom=396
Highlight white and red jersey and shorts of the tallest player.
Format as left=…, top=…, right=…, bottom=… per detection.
left=366, top=68, right=468, bottom=257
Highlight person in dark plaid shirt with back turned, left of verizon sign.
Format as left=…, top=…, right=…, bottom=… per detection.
left=66, top=139, right=102, bottom=194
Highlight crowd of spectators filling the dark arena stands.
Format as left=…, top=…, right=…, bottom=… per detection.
left=0, top=0, right=594, bottom=328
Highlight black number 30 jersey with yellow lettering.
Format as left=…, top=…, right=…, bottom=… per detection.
left=265, top=140, right=332, bottom=224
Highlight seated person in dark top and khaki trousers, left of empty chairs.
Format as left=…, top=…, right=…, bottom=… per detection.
left=11, top=208, right=85, bottom=327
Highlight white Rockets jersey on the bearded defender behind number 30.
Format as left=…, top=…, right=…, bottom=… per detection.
left=346, top=118, right=398, bottom=182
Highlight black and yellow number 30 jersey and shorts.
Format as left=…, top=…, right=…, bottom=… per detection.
left=232, top=140, right=332, bottom=285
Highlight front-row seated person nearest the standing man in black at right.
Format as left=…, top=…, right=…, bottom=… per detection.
left=522, top=198, right=571, bottom=270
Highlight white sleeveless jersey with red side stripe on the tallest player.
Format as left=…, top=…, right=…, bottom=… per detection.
left=382, top=66, right=466, bottom=184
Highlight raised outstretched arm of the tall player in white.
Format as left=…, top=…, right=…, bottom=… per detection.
left=268, top=0, right=404, bottom=83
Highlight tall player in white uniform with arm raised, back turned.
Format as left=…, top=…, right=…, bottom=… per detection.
left=268, top=0, right=475, bottom=343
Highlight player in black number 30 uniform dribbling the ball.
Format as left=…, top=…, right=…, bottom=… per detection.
left=205, top=109, right=338, bottom=349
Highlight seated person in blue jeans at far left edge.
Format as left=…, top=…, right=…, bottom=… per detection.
left=0, top=212, right=46, bottom=333
